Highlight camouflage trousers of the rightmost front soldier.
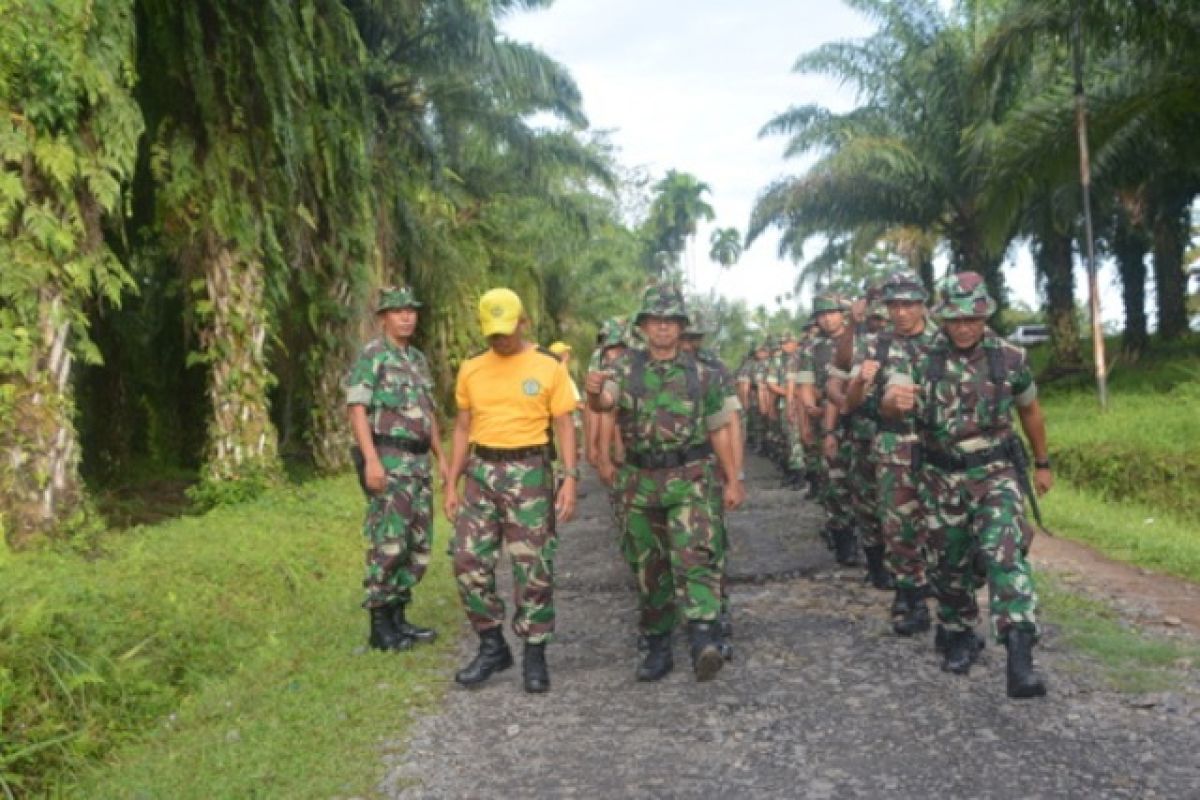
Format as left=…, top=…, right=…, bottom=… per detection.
left=920, top=464, right=1038, bottom=642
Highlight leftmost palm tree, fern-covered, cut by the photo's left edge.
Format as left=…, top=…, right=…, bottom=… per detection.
left=0, top=0, right=143, bottom=547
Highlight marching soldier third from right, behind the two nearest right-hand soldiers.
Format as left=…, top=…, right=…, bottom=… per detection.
left=796, top=291, right=856, bottom=564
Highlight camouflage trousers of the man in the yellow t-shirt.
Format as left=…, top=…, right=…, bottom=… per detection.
left=454, top=456, right=558, bottom=644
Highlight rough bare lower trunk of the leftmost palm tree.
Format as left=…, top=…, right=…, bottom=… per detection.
left=0, top=284, right=85, bottom=548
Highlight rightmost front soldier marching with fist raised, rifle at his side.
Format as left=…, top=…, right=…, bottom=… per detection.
left=882, top=272, right=1054, bottom=698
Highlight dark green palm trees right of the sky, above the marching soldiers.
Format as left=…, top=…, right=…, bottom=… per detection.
left=749, top=0, right=1200, bottom=357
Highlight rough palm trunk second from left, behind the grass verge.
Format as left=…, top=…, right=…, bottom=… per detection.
left=200, top=233, right=280, bottom=483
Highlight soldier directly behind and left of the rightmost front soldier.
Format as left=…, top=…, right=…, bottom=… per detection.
left=850, top=271, right=937, bottom=636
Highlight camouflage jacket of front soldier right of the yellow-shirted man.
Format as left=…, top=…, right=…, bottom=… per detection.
left=605, top=351, right=730, bottom=455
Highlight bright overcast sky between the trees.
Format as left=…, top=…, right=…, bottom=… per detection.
left=504, top=0, right=1121, bottom=319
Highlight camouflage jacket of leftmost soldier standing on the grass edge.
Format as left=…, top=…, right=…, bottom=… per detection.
left=342, top=337, right=433, bottom=467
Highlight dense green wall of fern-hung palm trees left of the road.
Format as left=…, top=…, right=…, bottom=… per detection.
left=0, top=0, right=667, bottom=545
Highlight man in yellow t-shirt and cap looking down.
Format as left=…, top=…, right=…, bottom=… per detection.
left=445, top=289, right=580, bottom=692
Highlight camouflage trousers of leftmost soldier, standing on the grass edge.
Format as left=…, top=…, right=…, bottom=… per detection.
left=362, top=462, right=433, bottom=608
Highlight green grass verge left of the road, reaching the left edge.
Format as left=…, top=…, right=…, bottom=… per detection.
left=0, top=477, right=462, bottom=798
